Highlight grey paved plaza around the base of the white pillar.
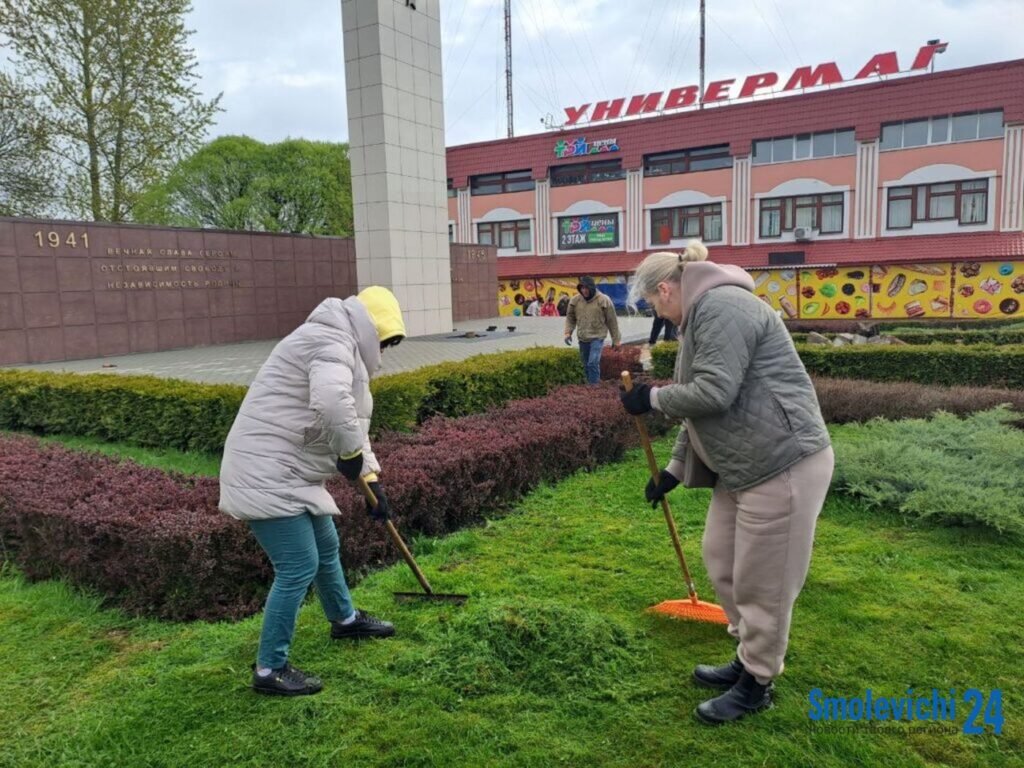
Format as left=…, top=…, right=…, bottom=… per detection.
left=9, top=317, right=651, bottom=384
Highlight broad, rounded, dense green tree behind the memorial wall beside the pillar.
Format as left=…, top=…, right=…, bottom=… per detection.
left=135, top=136, right=352, bottom=236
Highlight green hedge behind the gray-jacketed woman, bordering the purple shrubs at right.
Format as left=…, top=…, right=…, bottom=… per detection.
left=651, top=342, right=1024, bottom=389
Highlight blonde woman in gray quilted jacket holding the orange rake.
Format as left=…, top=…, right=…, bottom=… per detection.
left=621, top=242, right=834, bottom=723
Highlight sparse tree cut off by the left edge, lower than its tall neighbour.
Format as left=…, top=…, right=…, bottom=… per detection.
left=0, top=72, right=54, bottom=217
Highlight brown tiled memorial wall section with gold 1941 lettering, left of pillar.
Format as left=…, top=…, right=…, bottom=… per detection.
left=0, top=218, right=355, bottom=365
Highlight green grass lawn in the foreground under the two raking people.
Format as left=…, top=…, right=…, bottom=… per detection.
left=0, top=439, right=1024, bottom=768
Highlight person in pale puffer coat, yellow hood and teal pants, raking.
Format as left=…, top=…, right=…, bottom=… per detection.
left=219, top=286, right=406, bottom=696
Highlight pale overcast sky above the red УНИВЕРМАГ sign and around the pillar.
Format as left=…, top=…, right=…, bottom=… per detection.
left=188, top=0, right=1024, bottom=145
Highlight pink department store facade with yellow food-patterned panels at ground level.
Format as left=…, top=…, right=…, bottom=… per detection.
left=447, top=59, right=1024, bottom=318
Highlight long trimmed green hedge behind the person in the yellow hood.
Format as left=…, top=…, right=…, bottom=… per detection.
left=0, top=348, right=583, bottom=453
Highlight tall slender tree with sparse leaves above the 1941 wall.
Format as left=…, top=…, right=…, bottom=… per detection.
left=0, top=0, right=220, bottom=221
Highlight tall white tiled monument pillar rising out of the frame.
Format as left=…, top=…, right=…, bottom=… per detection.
left=341, top=0, right=452, bottom=336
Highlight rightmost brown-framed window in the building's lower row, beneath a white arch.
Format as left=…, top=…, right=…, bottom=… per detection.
left=887, top=179, right=988, bottom=229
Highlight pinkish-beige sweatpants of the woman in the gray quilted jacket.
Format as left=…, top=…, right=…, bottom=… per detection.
left=703, top=447, right=835, bottom=684
